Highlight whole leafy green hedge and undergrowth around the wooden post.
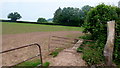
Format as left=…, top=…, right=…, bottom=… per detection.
left=82, top=4, right=120, bottom=65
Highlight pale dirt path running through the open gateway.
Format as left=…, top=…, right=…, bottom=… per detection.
left=46, top=40, right=87, bottom=66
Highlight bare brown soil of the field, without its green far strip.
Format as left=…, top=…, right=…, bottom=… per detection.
left=2, top=31, right=83, bottom=65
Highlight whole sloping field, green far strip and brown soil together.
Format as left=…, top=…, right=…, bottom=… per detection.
left=0, top=22, right=83, bottom=65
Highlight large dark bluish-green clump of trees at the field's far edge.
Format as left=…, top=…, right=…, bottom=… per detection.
left=53, top=5, right=92, bottom=26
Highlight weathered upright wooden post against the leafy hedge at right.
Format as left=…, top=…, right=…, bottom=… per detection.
left=104, top=21, right=115, bottom=66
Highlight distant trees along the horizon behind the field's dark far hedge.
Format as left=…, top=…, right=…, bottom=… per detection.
left=8, top=5, right=93, bottom=26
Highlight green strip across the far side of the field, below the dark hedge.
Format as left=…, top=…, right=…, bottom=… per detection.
left=0, top=22, right=83, bottom=34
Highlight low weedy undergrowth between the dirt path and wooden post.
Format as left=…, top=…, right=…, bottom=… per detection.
left=78, top=34, right=104, bottom=66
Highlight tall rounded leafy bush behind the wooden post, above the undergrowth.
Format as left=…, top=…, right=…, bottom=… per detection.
left=84, top=4, right=120, bottom=64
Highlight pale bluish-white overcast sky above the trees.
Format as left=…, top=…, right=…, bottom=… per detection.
left=0, top=0, right=120, bottom=21
